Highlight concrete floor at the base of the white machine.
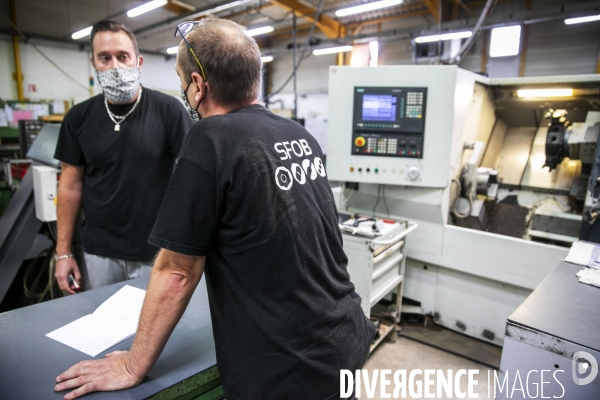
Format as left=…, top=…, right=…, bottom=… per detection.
left=360, top=337, right=494, bottom=399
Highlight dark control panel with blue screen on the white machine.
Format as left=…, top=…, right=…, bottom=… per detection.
left=351, top=87, right=427, bottom=158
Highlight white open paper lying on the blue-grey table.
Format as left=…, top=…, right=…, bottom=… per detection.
left=46, top=285, right=146, bottom=357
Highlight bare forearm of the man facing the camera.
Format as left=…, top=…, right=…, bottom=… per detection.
left=56, top=185, right=81, bottom=255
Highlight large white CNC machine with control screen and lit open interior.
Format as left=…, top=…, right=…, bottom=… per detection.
left=327, top=66, right=600, bottom=345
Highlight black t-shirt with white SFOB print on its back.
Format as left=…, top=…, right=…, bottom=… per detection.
left=150, top=105, right=375, bottom=400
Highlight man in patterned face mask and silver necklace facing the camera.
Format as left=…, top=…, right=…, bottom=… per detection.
left=54, top=21, right=192, bottom=294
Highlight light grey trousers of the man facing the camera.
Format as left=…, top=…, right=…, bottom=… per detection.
left=83, top=253, right=152, bottom=289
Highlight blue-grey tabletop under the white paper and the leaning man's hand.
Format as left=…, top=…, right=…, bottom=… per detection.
left=0, top=278, right=217, bottom=399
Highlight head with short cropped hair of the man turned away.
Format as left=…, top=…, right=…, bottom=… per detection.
left=177, top=18, right=262, bottom=107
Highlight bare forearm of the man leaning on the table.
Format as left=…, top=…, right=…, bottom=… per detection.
left=127, top=250, right=205, bottom=377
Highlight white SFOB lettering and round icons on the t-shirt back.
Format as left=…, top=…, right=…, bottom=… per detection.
left=273, top=139, right=326, bottom=190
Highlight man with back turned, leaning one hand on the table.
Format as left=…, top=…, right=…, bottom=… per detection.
left=55, top=18, right=375, bottom=400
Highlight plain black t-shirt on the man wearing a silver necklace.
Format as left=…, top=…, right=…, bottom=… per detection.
left=54, top=88, right=192, bottom=261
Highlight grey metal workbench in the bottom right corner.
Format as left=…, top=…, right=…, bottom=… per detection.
left=496, top=262, right=600, bottom=400
